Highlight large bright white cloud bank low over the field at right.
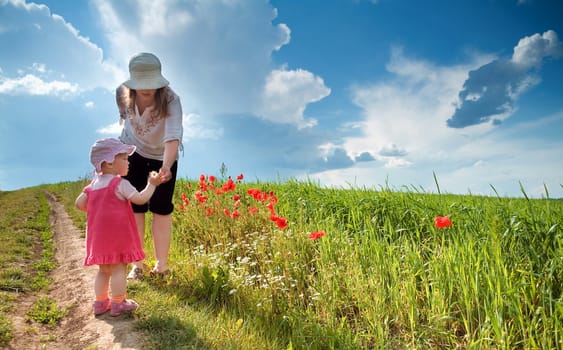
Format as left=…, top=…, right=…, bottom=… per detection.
left=309, top=51, right=563, bottom=197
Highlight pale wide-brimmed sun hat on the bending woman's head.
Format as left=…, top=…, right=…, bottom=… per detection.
left=123, top=52, right=169, bottom=90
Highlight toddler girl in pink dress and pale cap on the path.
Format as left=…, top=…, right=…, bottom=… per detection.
left=75, top=138, right=160, bottom=316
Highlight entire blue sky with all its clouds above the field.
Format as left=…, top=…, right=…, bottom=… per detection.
left=0, top=0, right=563, bottom=197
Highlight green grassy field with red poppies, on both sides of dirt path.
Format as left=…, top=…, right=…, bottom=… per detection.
left=0, top=177, right=563, bottom=349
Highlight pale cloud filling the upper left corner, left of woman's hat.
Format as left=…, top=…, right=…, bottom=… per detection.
left=0, top=1, right=122, bottom=94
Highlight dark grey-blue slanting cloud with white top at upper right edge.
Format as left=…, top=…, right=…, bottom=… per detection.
left=447, top=30, right=563, bottom=128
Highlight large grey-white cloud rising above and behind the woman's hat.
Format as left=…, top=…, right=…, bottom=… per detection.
left=94, top=0, right=330, bottom=127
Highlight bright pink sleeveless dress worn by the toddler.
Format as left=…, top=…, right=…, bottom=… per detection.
left=84, top=176, right=145, bottom=266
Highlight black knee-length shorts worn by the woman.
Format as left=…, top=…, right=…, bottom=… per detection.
left=124, top=152, right=178, bottom=215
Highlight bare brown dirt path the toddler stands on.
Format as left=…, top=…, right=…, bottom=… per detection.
left=8, top=194, right=147, bottom=350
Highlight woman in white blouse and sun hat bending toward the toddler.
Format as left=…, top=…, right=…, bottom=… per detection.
left=116, top=52, right=183, bottom=279
